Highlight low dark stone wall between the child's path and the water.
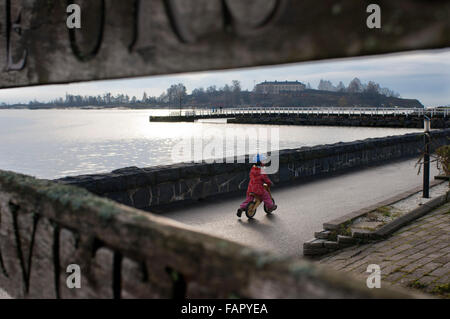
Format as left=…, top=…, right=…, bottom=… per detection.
left=58, top=129, right=450, bottom=211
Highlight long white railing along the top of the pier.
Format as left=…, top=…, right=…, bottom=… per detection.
left=169, top=107, right=450, bottom=117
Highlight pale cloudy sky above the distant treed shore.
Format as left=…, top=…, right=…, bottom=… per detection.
left=0, top=48, right=450, bottom=107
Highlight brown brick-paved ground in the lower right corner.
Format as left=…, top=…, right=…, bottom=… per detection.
left=320, top=203, right=450, bottom=298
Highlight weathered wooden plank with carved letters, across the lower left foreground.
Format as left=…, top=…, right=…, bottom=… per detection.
left=0, top=171, right=420, bottom=298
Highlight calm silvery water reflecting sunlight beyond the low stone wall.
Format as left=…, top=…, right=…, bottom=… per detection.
left=0, top=110, right=420, bottom=178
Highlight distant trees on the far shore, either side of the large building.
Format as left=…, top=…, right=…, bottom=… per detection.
left=1, top=78, right=400, bottom=108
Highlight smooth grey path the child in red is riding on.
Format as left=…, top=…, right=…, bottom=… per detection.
left=164, top=159, right=437, bottom=257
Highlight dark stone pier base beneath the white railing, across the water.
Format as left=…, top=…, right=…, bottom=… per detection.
left=149, top=113, right=450, bottom=129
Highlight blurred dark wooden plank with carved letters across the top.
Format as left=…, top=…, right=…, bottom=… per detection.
left=0, top=0, right=450, bottom=88
